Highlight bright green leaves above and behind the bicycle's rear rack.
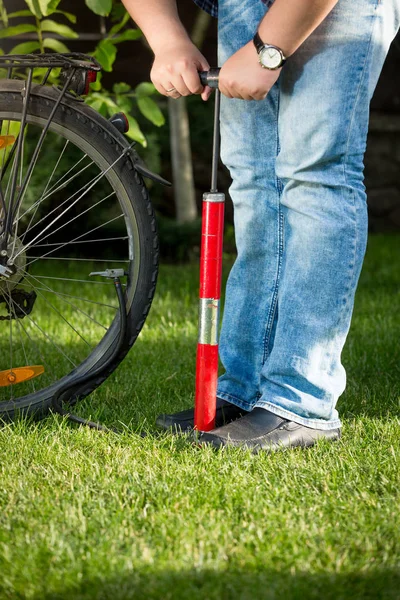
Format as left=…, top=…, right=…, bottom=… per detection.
left=0, top=0, right=165, bottom=146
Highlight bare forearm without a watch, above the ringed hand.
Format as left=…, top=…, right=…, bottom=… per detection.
left=122, top=0, right=191, bottom=54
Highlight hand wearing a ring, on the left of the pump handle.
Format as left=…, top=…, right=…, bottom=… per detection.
left=150, top=41, right=212, bottom=100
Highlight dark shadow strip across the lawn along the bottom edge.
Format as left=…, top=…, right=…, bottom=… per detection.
left=35, top=567, right=400, bottom=600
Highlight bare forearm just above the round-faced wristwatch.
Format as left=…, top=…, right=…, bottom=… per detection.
left=258, top=0, right=338, bottom=56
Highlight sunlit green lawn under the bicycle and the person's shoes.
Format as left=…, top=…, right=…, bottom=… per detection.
left=0, top=235, right=400, bottom=600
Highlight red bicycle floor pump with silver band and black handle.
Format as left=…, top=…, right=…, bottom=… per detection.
left=194, top=69, right=225, bottom=431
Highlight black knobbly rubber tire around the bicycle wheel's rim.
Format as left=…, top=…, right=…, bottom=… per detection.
left=0, top=80, right=158, bottom=419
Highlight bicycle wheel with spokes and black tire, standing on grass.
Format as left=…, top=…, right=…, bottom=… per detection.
left=0, top=80, right=158, bottom=418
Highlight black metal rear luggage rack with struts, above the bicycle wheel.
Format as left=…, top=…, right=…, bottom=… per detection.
left=0, top=52, right=101, bottom=256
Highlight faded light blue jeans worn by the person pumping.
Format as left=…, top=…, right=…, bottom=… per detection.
left=218, top=0, right=400, bottom=430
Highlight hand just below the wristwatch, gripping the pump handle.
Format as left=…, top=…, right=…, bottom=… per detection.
left=218, top=41, right=282, bottom=100
